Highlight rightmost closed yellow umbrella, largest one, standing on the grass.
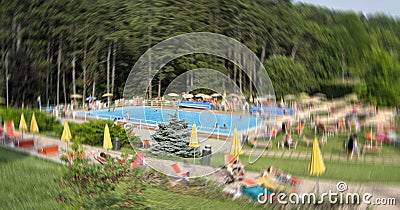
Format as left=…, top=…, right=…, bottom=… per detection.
left=308, top=138, right=325, bottom=195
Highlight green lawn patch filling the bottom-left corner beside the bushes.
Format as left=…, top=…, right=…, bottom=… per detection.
left=0, top=147, right=67, bottom=209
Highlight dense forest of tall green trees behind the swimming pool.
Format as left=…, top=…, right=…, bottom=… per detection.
left=0, top=0, right=400, bottom=106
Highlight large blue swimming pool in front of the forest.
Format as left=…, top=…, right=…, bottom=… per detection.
left=75, top=106, right=262, bottom=135
